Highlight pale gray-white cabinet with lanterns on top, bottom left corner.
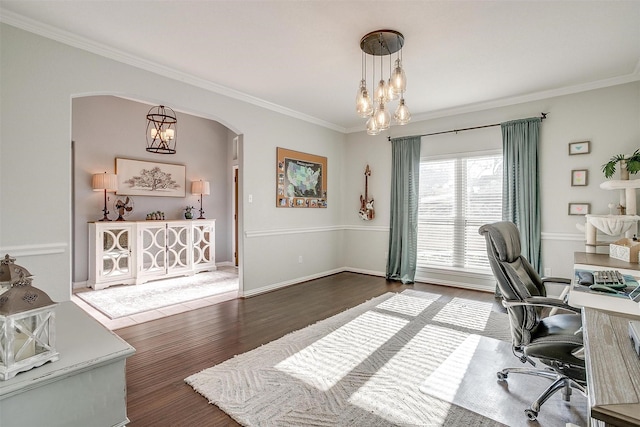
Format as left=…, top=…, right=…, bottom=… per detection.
left=0, top=301, right=135, bottom=427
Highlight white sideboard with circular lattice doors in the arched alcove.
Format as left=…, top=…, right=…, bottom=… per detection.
left=89, top=220, right=216, bottom=289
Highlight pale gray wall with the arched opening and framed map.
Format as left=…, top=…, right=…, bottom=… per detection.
left=0, top=23, right=346, bottom=301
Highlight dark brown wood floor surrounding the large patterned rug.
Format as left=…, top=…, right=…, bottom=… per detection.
left=115, top=273, right=502, bottom=427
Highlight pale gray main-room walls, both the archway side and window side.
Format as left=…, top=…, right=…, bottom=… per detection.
left=0, top=20, right=640, bottom=301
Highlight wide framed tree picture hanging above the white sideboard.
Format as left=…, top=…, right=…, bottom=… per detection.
left=116, top=158, right=186, bottom=197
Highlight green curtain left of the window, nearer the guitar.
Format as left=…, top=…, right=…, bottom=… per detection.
left=386, top=136, right=420, bottom=284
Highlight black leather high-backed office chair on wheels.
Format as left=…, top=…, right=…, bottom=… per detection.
left=478, top=221, right=587, bottom=421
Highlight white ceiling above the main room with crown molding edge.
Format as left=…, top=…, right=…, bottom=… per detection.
left=0, top=0, right=640, bottom=132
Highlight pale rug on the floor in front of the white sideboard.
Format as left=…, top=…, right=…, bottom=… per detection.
left=76, top=270, right=238, bottom=319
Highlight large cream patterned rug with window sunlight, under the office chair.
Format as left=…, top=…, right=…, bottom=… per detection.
left=185, top=290, right=584, bottom=426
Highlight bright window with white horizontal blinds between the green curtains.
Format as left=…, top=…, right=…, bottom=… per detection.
left=417, top=152, right=502, bottom=270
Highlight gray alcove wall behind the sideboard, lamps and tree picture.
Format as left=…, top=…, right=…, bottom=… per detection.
left=71, top=96, right=233, bottom=283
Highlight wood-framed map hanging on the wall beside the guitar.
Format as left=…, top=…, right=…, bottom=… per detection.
left=276, top=147, right=327, bottom=208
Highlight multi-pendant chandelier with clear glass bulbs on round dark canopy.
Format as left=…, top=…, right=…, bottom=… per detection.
left=356, top=30, right=411, bottom=135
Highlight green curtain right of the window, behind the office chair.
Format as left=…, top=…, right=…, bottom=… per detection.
left=500, top=117, right=541, bottom=273
